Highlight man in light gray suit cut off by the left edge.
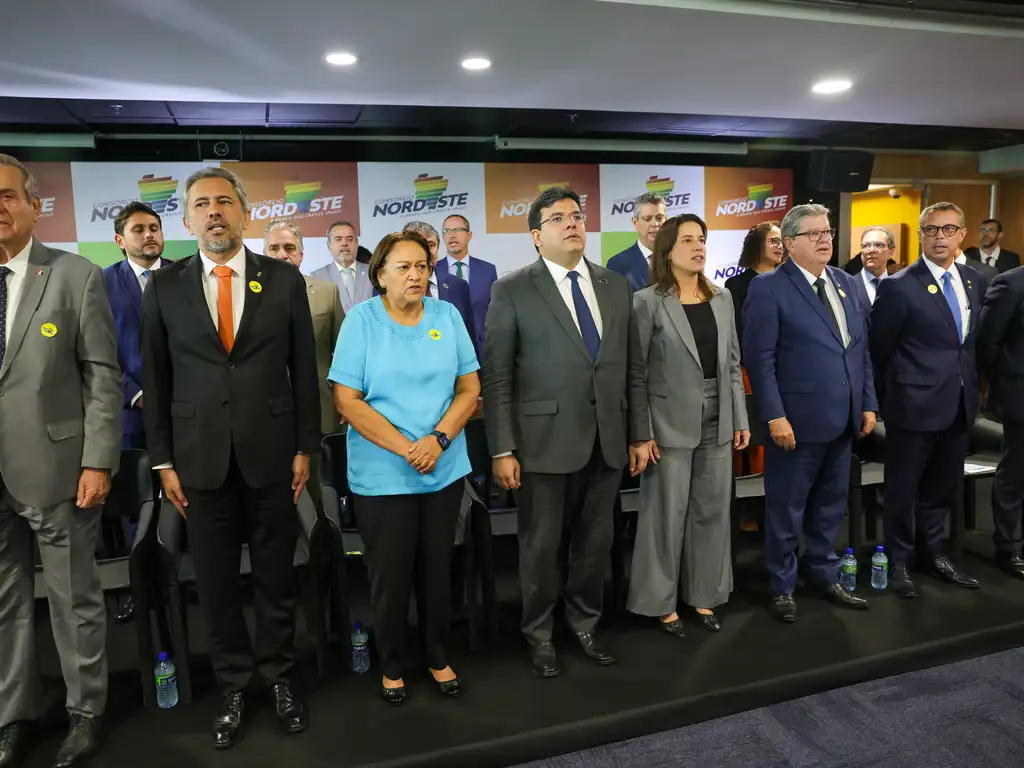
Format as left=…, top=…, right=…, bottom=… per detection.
left=0, top=155, right=123, bottom=768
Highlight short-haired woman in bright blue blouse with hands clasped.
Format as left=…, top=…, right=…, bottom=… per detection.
left=328, top=232, right=480, bottom=706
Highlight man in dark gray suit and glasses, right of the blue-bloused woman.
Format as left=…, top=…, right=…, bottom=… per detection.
left=483, top=187, right=651, bottom=677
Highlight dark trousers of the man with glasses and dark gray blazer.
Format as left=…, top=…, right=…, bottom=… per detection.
left=517, top=444, right=623, bottom=645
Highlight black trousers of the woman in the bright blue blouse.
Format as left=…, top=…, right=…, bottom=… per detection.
left=353, top=478, right=465, bottom=680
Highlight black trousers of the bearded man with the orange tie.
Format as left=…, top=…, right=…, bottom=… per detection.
left=183, top=456, right=299, bottom=695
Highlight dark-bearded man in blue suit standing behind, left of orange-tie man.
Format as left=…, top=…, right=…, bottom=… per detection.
left=103, top=201, right=171, bottom=624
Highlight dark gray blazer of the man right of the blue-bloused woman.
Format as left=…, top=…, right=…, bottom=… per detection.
left=483, top=259, right=650, bottom=474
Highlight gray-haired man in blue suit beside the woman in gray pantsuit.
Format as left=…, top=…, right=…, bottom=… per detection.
left=742, top=205, right=878, bottom=622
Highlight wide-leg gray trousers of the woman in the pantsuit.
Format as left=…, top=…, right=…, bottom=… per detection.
left=627, top=382, right=732, bottom=616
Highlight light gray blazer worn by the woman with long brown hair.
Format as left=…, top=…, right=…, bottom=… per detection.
left=633, top=286, right=750, bottom=449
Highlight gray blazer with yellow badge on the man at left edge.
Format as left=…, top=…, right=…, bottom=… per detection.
left=0, top=241, right=124, bottom=507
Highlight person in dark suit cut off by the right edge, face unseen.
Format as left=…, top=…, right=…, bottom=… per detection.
left=978, top=267, right=1024, bottom=579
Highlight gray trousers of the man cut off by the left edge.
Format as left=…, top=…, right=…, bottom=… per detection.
left=0, top=481, right=106, bottom=727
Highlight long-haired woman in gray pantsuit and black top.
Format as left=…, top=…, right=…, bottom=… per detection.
left=628, top=214, right=751, bottom=637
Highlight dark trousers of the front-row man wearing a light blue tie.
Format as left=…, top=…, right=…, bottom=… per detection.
left=884, top=397, right=968, bottom=565
